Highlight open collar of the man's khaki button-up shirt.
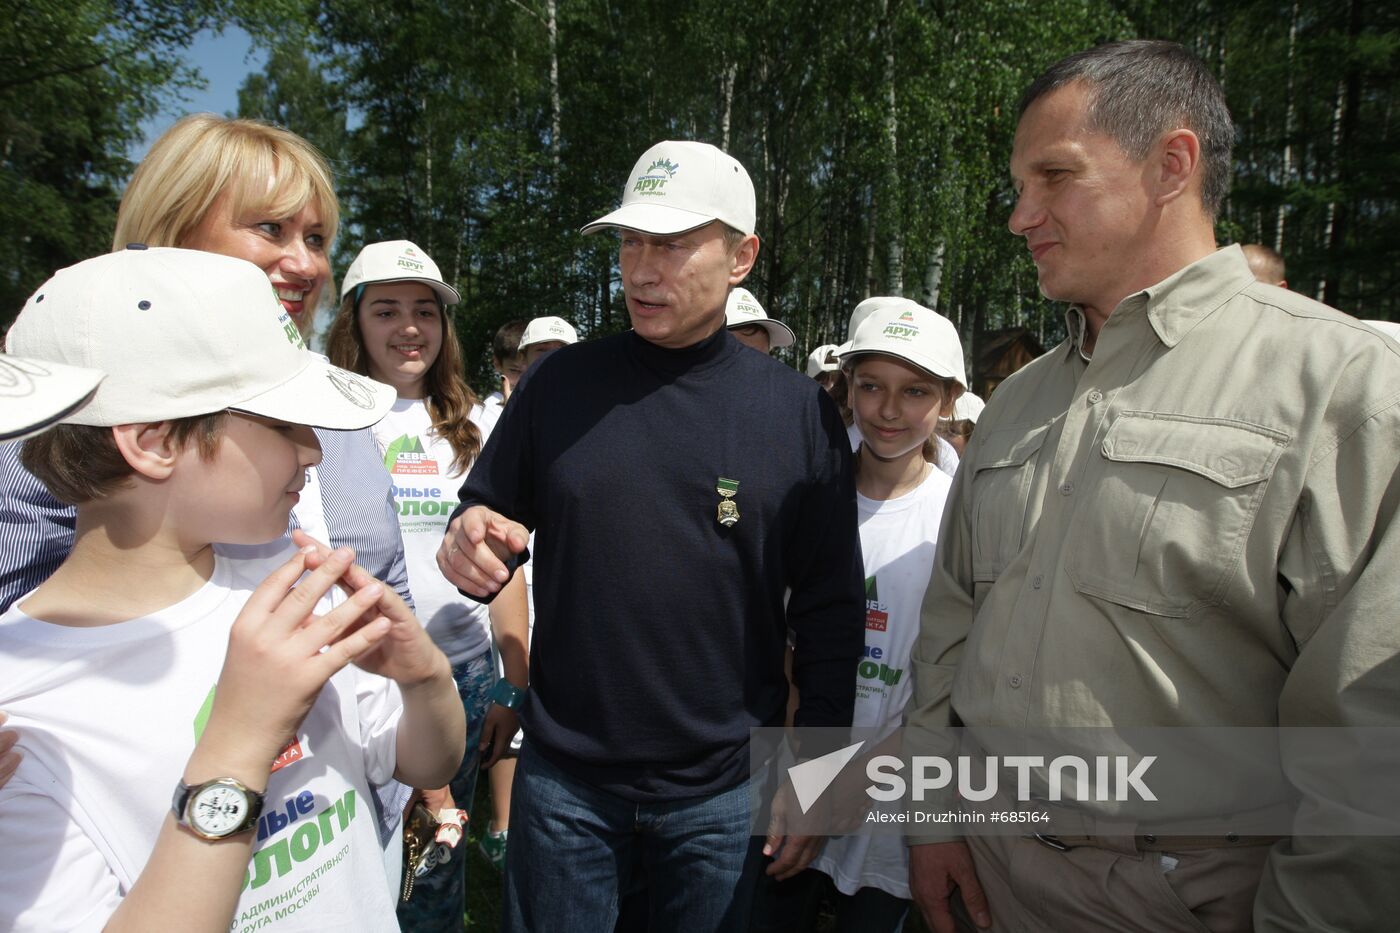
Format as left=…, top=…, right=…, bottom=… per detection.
left=1065, top=245, right=1254, bottom=360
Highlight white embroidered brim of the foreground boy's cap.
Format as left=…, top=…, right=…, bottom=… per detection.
left=228, top=353, right=399, bottom=431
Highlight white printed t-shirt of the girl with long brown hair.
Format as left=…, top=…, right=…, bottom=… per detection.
left=374, top=398, right=491, bottom=665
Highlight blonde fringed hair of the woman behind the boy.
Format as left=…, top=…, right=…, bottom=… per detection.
left=112, top=113, right=340, bottom=249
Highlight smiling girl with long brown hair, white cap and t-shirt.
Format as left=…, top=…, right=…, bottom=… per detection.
left=326, top=240, right=529, bottom=930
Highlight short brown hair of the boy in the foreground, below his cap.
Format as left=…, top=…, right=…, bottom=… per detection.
left=20, top=412, right=224, bottom=506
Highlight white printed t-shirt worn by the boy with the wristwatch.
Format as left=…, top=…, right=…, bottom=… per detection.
left=0, top=549, right=402, bottom=933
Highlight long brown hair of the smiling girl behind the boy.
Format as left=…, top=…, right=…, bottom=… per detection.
left=326, top=280, right=482, bottom=474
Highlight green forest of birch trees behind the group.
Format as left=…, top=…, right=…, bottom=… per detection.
left=0, top=0, right=1400, bottom=388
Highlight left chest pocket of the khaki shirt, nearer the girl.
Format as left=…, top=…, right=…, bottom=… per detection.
left=972, top=424, right=1050, bottom=583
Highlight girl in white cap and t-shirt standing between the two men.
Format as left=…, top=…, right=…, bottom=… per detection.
left=752, top=300, right=966, bottom=933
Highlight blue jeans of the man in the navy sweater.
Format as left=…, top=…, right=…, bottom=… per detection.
left=501, top=738, right=763, bottom=933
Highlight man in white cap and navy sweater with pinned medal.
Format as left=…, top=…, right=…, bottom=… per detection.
left=438, top=141, right=864, bottom=932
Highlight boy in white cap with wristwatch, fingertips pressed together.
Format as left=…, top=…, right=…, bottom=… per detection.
left=0, top=248, right=463, bottom=930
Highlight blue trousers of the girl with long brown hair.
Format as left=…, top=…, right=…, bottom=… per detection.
left=399, top=651, right=501, bottom=933
